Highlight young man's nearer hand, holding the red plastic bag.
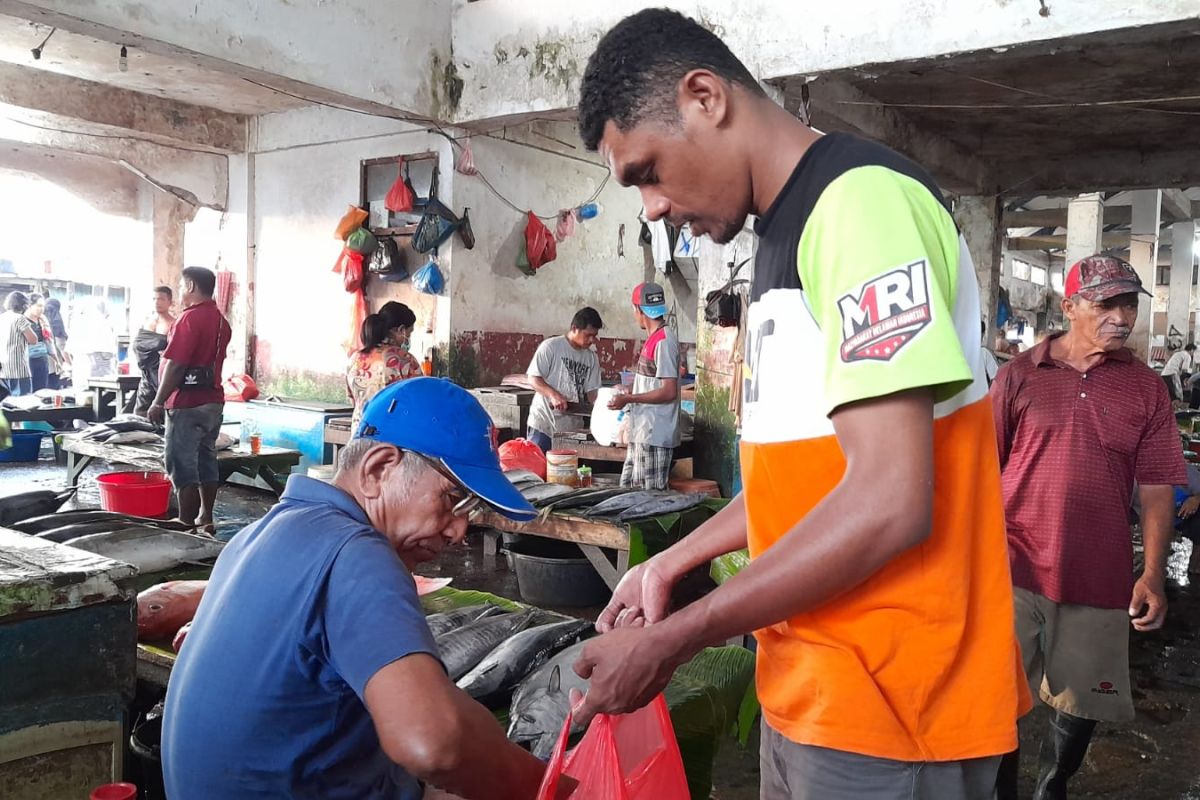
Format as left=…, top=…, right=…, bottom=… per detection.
left=575, top=626, right=679, bottom=726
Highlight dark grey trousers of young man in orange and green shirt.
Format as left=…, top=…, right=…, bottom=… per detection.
left=758, top=721, right=1001, bottom=800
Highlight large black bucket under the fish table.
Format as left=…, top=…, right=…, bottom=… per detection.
left=508, top=536, right=612, bottom=607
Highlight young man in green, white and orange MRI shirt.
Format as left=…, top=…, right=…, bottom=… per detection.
left=576, top=10, right=1030, bottom=800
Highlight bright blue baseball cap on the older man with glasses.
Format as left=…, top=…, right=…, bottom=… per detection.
left=355, top=378, right=538, bottom=521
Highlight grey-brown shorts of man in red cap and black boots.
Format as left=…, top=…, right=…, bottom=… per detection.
left=1013, top=587, right=1133, bottom=722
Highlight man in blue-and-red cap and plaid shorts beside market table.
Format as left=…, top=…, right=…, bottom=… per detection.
left=608, top=283, right=679, bottom=489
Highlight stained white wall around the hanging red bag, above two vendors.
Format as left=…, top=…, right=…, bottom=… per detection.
left=452, top=122, right=696, bottom=342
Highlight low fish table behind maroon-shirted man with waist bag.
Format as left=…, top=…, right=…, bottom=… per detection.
left=62, top=437, right=300, bottom=497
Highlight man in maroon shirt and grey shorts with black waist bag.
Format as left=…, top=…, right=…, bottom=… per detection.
left=146, top=266, right=232, bottom=534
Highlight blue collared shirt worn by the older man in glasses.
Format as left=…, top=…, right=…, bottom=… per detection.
left=162, top=475, right=437, bottom=800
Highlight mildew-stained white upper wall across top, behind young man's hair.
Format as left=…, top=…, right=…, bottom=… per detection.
left=454, top=0, right=1196, bottom=121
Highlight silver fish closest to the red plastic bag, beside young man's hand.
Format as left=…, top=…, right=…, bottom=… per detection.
left=509, top=642, right=588, bottom=760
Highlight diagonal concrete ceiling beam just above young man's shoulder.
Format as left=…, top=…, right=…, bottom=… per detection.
left=784, top=77, right=996, bottom=194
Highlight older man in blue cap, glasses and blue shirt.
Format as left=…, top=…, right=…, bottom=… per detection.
left=162, top=378, right=566, bottom=800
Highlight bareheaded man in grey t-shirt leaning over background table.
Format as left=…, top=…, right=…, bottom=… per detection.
left=526, top=306, right=604, bottom=452
